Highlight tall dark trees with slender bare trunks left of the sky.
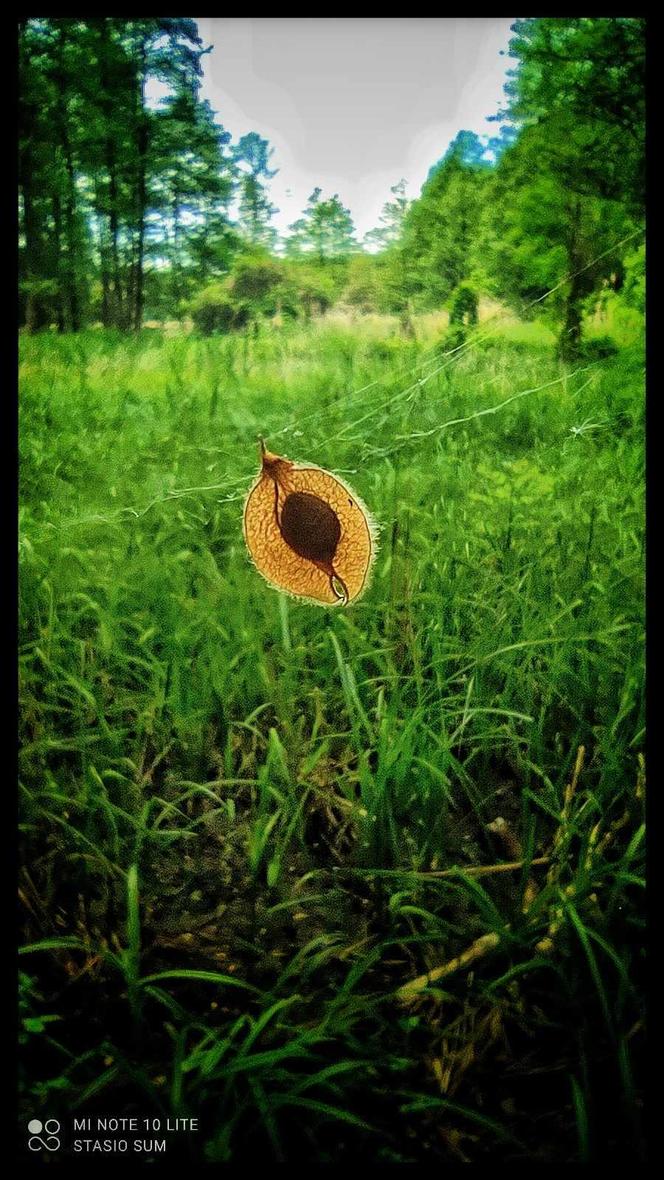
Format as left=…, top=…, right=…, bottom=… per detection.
left=19, top=17, right=246, bottom=330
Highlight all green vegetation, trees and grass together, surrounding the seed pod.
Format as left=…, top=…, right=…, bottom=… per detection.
left=19, top=18, right=645, bottom=1165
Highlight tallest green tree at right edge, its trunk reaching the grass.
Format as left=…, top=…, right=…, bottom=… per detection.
left=489, top=17, right=645, bottom=358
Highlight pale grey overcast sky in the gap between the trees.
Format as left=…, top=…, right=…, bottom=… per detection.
left=195, top=17, right=515, bottom=237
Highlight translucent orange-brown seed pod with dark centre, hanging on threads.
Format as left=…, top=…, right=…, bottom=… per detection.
left=243, top=441, right=376, bottom=607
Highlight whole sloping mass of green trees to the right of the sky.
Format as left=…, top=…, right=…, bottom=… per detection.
left=386, top=18, right=644, bottom=349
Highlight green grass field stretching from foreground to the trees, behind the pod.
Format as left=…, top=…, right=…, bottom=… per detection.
left=19, top=309, right=645, bottom=1163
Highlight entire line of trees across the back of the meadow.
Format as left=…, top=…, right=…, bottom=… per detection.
left=19, top=17, right=645, bottom=354
